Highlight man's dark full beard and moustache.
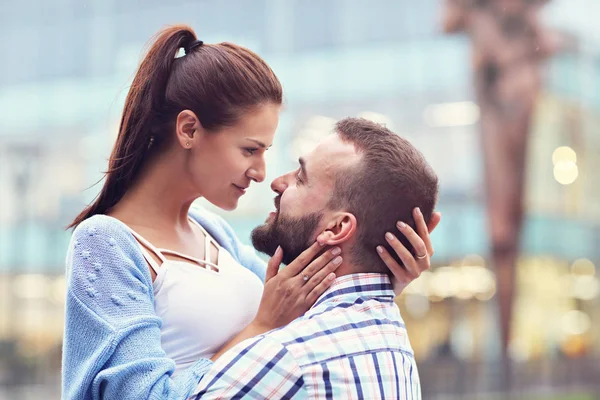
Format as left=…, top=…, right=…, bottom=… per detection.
left=251, top=206, right=323, bottom=265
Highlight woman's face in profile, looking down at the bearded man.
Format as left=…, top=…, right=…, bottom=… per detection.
left=188, top=104, right=281, bottom=210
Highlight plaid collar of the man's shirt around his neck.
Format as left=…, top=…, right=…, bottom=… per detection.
left=312, top=273, right=395, bottom=309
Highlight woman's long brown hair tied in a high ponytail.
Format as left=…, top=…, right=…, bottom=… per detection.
left=69, top=25, right=282, bottom=228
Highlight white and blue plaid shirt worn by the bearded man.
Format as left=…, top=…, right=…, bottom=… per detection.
left=194, top=273, right=421, bottom=400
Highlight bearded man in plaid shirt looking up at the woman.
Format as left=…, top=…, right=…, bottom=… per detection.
left=197, top=118, right=438, bottom=400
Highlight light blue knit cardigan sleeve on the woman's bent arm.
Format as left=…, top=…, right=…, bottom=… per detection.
left=62, top=216, right=212, bottom=400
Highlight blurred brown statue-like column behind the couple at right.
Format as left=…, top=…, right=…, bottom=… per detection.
left=443, top=0, right=558, bottom=359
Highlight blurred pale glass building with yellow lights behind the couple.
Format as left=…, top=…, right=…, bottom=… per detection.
left=0, top=0, right=600, bottom=398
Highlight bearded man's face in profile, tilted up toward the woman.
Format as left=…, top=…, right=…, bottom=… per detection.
left=252, top=134, right=360, bottom=264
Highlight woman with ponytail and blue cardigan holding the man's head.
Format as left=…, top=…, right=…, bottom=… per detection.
left=63, top=26, right=439, bottom=399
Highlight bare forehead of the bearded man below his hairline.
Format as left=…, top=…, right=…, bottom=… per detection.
left=304, top=134, right=360, bottom=177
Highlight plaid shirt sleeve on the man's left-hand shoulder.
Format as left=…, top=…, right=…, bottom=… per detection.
left=191, top=336, right=308, bottom=400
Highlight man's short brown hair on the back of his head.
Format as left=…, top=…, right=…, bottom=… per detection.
left=328, top=118, right=438, bottom=273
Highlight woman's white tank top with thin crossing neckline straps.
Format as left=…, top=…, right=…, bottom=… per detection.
left=130, top=219, right=263, bottom=375
